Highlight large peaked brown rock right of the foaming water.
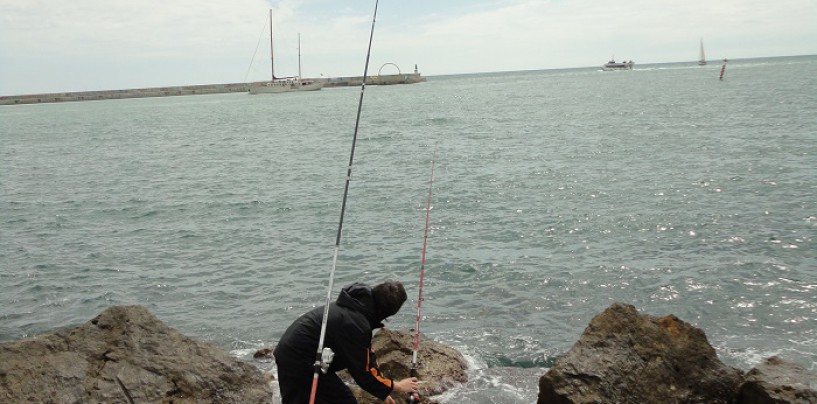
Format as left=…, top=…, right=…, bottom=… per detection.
left=538, top=303, right=743, bottom=404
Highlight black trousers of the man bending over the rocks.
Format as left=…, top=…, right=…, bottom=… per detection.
left=275, top=358, right=357, bottom=404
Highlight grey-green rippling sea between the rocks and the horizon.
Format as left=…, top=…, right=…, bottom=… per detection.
left=0, top=56, right=817, bottom=404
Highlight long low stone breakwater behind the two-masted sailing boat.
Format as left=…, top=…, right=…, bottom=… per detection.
left=0, top=73, right=426, bottom=105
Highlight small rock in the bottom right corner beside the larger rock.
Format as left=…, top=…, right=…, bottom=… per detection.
left=737, top=356, right=817, bottom=404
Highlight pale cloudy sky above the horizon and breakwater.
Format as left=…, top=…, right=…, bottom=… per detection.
left=0, top=0, right=817, bottom=96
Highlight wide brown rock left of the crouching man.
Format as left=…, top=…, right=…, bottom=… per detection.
left=0, top=306, right=272, bottom=404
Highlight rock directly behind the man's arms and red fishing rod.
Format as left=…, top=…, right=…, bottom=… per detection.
left=342, top=328, right=468, bottom=404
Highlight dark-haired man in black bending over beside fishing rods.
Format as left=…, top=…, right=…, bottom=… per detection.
left=273, top=281, right=417, bottom=404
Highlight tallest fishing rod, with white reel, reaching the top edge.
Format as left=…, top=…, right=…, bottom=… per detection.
left=309, top=0, right=379, bottom=404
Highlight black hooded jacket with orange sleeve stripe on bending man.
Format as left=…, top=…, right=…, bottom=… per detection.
left=273, top=283, right=394, bottom=400
